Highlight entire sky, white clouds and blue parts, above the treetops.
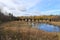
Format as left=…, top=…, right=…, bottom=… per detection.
left=0, top=0, right=60, bottom=16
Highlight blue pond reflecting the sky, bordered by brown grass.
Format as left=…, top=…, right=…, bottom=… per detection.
left=32, top=23, right=60, bottom=32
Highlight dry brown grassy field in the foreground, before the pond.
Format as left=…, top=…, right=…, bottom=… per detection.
left=0, top=21, right=60, bottom=40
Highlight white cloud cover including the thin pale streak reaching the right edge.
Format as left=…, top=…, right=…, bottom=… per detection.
left=0, top=0, right=60, bottom=16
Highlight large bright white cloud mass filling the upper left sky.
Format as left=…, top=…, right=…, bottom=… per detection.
left=0, top=0, right=40, bottom=15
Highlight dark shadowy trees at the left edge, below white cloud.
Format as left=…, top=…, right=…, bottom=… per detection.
left=0, top=11, right=19, bottom=22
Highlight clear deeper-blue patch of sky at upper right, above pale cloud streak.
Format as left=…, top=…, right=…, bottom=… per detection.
left=36, top=0, right=60, bottom=11
